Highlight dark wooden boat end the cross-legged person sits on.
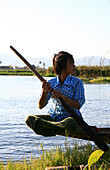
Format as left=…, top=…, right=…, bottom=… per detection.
left=58, top=126, right=110, bottom=144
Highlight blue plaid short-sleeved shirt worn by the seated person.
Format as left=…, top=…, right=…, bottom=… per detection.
left=45, top=75, right=85, bottom=121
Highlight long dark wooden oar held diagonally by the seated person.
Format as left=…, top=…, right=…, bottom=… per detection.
left=10, top=46, right=109, bottom=152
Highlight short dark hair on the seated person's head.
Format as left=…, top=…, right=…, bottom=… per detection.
left=53, top=51, right=74, bottom=75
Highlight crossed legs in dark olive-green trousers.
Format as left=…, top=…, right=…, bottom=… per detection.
left=26, top=115, right=81, bottom=136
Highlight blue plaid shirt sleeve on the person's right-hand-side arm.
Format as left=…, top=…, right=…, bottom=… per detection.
left=74, top=79, right=85, bottom=108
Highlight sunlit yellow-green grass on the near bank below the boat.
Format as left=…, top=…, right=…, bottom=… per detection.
left=0, top=140, right=110, bottom=170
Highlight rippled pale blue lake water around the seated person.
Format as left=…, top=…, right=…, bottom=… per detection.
left=0, top=76, right=110, bottom=161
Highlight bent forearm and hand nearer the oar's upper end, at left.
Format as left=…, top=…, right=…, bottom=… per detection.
left=38, top=81, right=52, bottom=109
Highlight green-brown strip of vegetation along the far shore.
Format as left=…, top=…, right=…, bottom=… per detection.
left=0, top=66, right=110, bottom=78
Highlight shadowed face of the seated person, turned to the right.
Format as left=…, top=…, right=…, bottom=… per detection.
left=66, top=60, right=75, bottom=74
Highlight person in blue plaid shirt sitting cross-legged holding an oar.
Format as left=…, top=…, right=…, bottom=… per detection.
left=26, top=51, right=85, bottom=136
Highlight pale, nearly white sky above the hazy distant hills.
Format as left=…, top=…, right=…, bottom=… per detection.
left=0, top=0, right=110, bottom=58
